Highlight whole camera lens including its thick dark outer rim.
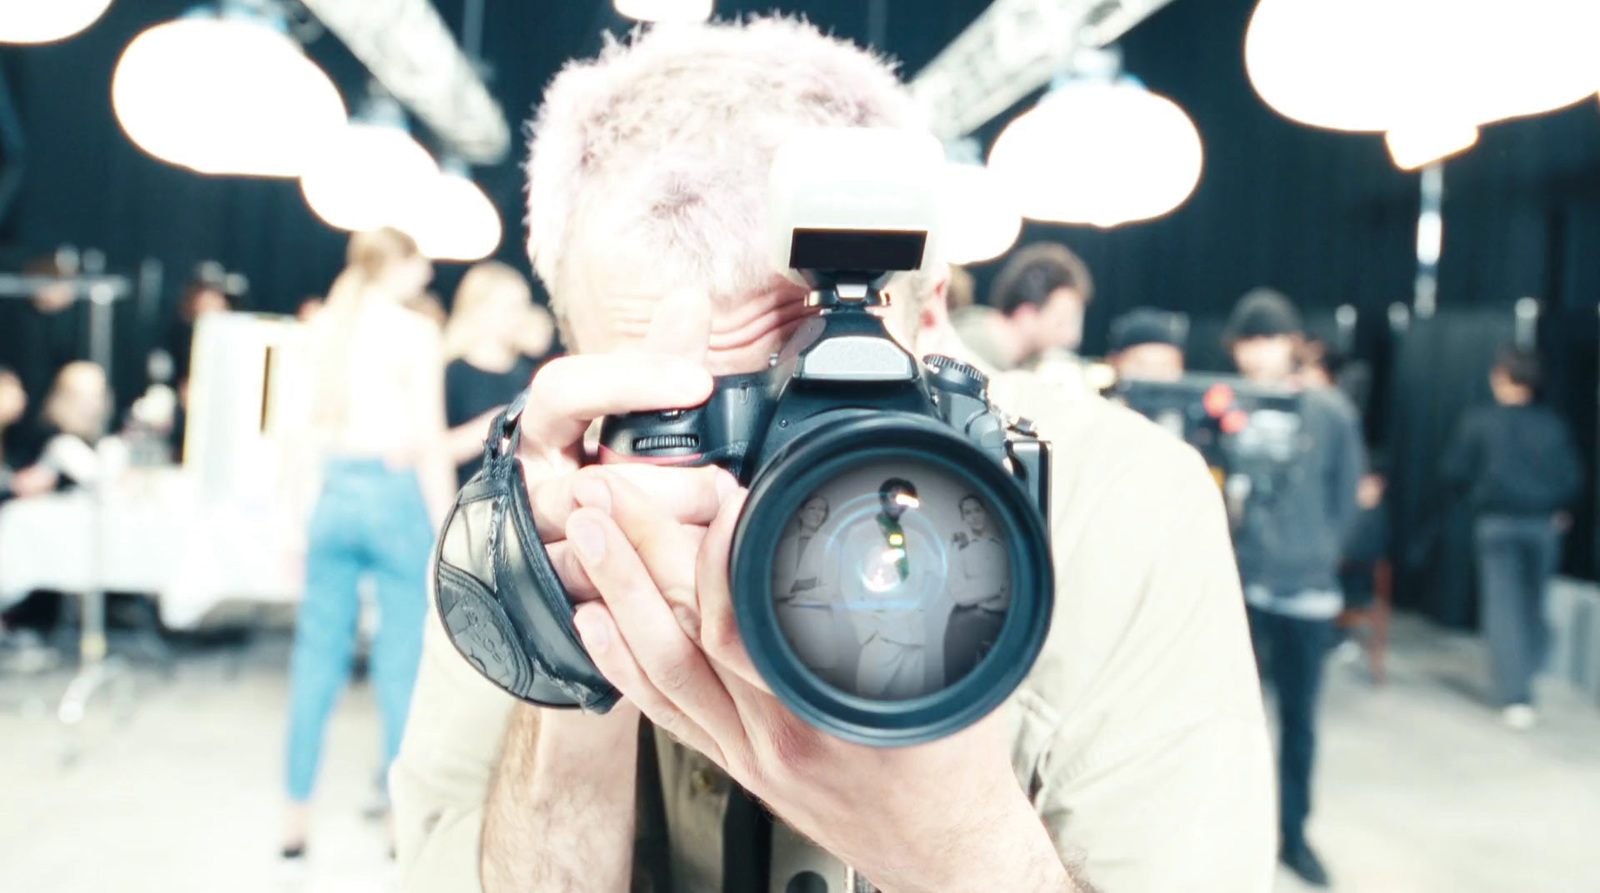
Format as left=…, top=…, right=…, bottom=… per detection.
left=731, top=411, right=1054, bottom=746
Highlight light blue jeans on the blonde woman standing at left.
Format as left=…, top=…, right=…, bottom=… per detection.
left=288, top=459, right=434, bottom=802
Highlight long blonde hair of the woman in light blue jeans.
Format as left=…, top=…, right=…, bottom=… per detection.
left=312, top=226, right=421, bottom=426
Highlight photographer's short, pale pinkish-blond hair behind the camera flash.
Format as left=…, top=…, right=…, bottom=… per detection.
left=528, top=18, right=922, bottom=318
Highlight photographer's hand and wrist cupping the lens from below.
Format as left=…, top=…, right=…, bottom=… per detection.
left=566, top=469, right=1074, bottom=893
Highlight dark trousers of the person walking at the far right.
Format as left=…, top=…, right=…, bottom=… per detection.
left=1474, top=515, right=1562, bottom=704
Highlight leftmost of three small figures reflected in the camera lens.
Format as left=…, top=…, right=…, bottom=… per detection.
left=774, top=495, right=840, bottom=675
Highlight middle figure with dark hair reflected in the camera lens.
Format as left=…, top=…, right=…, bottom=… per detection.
left=842, top=477, right=941, bottom=699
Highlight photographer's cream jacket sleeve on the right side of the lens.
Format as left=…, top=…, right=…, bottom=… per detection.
left=1024, top=416, right=1277, bottom=893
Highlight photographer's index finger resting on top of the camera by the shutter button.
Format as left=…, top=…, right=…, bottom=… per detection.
left=522, top=352, right=710, bottom=459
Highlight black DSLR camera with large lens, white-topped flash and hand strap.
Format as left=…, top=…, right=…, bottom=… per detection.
left=437, top=130, right=1054, bottom=746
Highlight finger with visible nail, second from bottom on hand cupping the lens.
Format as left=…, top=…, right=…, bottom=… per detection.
left=566, top=509, right=744, bottom=752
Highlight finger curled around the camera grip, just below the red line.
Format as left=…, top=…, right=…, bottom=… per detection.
left=528, top=463, right=733, bottom=543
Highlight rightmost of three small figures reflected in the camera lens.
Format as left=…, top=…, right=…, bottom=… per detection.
left=944, top=493, right=1011, bottom=685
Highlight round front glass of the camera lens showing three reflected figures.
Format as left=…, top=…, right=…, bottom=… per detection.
left=771, top=461, right=1011, bottom=701
